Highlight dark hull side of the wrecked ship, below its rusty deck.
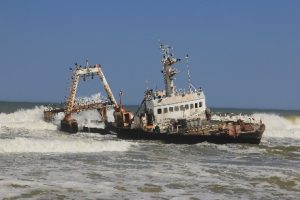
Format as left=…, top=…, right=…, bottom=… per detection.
left=108, top=125, right=265, bottom=144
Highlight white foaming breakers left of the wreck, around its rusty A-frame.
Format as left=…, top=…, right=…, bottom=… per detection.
left=0, top=106, right=133, bottom=154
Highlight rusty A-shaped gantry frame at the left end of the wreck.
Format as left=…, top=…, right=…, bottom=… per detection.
left=44, top=59, right=132, bottom=133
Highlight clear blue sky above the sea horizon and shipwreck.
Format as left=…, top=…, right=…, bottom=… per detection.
left=0, top=0, right=300, bottom=109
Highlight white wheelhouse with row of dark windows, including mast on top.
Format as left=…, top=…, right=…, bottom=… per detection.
left=134, top=44, right=209, bottom=129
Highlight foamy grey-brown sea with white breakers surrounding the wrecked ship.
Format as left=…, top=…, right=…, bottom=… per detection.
left=0, top=102, right=300, bottom=199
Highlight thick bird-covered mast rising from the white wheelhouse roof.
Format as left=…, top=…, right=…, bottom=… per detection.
left=160, top=44, right=180, bottom=97
